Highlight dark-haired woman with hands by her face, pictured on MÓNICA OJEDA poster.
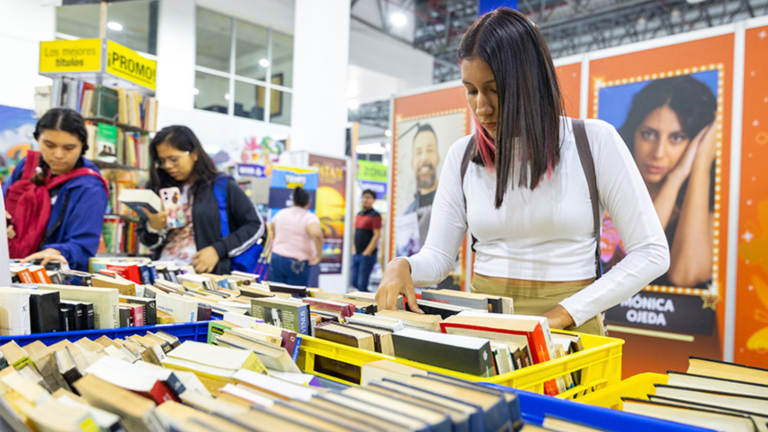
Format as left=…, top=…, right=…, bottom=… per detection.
left=612, top=76, right=717, bottom=288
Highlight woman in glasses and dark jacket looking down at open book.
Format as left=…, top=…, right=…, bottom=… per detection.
left=137, top=126, right=265, bottom=274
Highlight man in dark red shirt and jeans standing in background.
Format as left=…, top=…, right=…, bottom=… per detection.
left=351, top=189, right=381, bottom=291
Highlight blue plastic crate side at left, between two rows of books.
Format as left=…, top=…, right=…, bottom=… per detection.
left=0, top=321, right=208, bottom=347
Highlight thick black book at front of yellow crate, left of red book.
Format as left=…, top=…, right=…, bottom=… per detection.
left=392, top=330, right=494, bottom=377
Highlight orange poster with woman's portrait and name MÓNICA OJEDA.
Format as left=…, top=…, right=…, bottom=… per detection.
left=589, top=35, right=734, bottom=375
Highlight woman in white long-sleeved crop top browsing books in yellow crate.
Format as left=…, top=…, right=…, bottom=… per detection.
left=376, top=9, right=669, bottom=334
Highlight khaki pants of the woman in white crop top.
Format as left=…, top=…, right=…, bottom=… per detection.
left=470, top=274, right=605, bottom=336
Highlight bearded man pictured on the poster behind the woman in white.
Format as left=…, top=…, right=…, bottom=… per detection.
left=404, top=123, right=440, bottom=247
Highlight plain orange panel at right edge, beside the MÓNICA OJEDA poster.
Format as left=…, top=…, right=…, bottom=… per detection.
left=734, top=27, right=768, bottom=367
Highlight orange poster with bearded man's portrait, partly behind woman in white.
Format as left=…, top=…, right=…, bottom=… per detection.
left=388, top=87, right=472, bottom=289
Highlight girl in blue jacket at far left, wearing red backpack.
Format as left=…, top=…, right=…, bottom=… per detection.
left=3, top=108, right=108, bottom=271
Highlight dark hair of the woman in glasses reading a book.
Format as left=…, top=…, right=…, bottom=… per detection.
left=147, top=126, right=219, bottom=198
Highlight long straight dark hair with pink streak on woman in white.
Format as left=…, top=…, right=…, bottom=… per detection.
left=458, top=8, right=564, bottom=208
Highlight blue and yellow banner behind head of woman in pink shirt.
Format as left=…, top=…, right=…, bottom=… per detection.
left=269, top=166, right=319, bottom=220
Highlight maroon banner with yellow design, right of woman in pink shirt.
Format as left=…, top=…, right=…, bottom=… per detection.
left=309, top=154, right=347, bottom=274
